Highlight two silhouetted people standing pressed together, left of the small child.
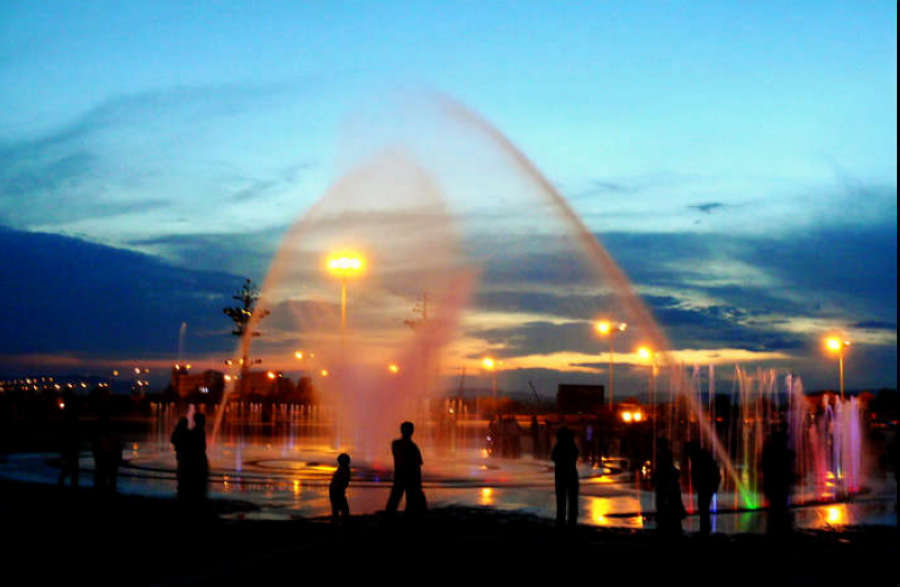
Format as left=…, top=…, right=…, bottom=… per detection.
left=172, top=404, right=209, bottom=505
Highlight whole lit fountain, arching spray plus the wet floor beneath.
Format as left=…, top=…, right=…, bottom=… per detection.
left=0, top=97, right=884, bottom=528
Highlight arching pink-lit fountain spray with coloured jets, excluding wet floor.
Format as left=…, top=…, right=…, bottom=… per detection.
left=206, top=97, right=872, bottom=520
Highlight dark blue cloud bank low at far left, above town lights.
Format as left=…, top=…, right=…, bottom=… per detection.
left=0, top=229, right=242, bottom=358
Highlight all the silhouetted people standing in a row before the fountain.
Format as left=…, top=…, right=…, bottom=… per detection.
left=153, top=408, right=794, bottom=536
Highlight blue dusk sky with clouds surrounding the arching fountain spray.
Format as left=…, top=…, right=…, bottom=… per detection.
left=0, top=1, right=897, bottom=396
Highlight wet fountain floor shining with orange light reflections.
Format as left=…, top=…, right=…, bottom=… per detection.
left=0, top=438, right=897, bottom=533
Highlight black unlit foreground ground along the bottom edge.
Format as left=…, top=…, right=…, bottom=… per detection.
left=0, top=481, right=900, bottom=586
